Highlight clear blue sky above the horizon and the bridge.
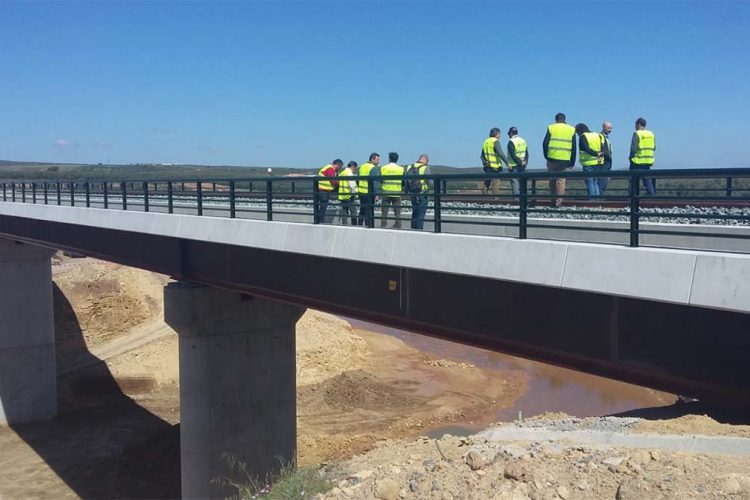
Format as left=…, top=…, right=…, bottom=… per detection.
left=0, top=1, right=750, bottom=168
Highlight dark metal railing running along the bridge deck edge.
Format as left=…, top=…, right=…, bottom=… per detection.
left=2, top=169, right=750, bottom=251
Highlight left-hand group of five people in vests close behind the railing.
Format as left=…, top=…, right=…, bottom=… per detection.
left=315, top=153, right=434, bottom=230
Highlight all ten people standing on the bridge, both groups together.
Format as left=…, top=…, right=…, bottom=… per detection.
left=315, top=113, right=656, bottom=230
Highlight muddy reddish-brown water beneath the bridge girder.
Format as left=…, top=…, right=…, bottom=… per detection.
left=346, top=318, right=674, bottom=422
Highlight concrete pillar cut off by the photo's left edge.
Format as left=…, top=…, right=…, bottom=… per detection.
left=0, top=238, right=57, bottom=424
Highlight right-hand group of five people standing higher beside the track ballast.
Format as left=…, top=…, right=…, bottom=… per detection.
left=480, top=113, right=656, bottom=206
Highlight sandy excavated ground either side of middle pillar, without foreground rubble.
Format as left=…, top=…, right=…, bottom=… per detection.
left=0, top=257, right=526, bottom=499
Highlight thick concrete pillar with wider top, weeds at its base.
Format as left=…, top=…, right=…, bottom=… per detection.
left=164, top=282, right=304, bottom=498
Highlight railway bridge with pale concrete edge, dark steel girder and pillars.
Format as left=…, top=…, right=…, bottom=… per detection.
left=0, top=170, right=750, bottom=498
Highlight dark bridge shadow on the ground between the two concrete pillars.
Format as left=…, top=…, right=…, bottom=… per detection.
left=8, top=285, right=180, bottom=498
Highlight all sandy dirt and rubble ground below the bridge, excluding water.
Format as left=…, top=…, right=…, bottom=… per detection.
left=0, top=256, right=750, bottom=499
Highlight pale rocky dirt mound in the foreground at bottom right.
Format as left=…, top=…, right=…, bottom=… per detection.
left=324, top=422, right=750, bottom=500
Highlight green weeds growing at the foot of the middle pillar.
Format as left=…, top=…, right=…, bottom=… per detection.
left=211, top=454, right=331, bottom=500
